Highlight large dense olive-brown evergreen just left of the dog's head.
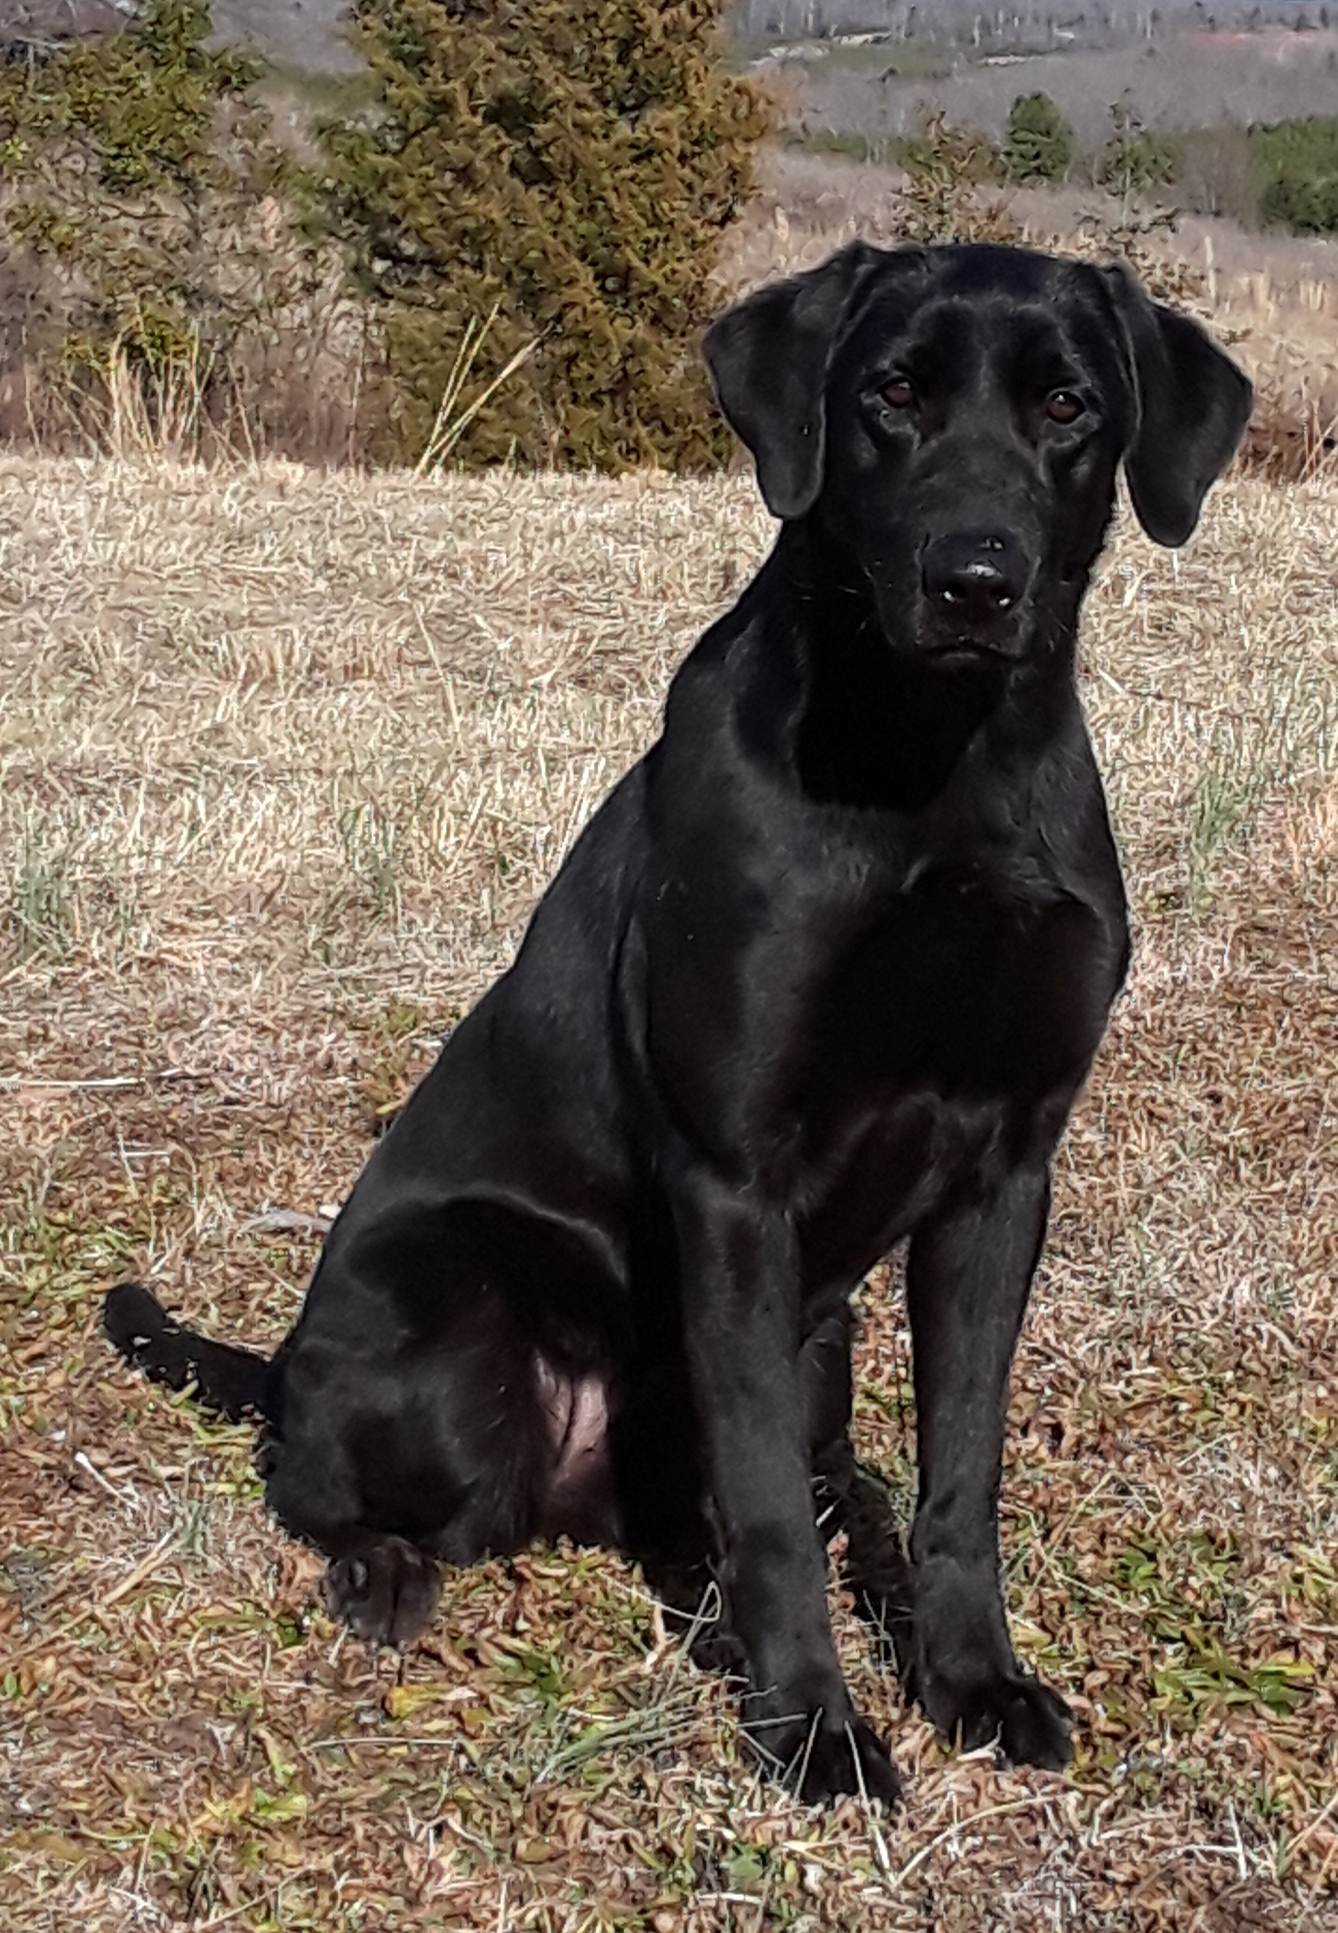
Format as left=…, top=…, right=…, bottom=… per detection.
left=323, top=0, right=770, bottom=470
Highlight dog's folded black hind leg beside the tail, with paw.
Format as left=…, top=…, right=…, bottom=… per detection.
left=267, top=1204, right=626, bottom=1643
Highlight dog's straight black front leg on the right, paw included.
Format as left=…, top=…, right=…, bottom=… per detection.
left=905, top=1164, right=1071, bottom=1769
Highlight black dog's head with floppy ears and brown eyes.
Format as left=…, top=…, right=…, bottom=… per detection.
left=706, top=242, right=1251, bottom=665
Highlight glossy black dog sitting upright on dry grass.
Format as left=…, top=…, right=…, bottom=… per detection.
left=106, top=244, right=1251, bottom=1800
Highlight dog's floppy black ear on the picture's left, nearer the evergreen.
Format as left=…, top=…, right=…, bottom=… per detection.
left=704, top=242, right=886, bottom=518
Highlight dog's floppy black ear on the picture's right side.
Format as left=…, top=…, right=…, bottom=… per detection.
left=1104, top=263, right=1255, bottom=549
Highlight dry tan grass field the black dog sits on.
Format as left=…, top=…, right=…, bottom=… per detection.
left=0, top=444, right=1338, bottom=1933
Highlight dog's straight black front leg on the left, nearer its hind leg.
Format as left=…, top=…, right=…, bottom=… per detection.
left=675, top=1168, right=897, bottom=1803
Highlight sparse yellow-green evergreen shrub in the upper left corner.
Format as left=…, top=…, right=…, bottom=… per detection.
left=0, top=0, right=320, bottom=443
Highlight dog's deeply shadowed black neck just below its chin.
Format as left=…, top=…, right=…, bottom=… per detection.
left=758, top=522, right=1077, bottom=812
